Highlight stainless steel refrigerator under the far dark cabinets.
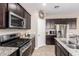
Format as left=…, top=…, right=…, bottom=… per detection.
left=56, top=24, right=67, bottom=38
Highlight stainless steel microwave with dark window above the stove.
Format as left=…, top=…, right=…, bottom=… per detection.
left=9, top=12, right=25, bottom=28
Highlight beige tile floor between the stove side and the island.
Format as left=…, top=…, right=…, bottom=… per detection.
left=32, top=45, right=55, bottom=56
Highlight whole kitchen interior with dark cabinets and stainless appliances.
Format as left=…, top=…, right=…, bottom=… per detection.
left=0, top=3, right=79, bottom=56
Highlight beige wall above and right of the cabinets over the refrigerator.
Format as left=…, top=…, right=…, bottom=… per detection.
left=46, top=13, right=79, bottom=35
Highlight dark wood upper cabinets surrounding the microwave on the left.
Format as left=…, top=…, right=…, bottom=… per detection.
left=0, top=3, right=31, bottom=29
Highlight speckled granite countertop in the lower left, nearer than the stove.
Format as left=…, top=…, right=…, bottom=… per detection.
left=0, top=46, right=18, bottom=56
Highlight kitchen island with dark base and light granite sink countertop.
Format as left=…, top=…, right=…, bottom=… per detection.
left=55, top=38, right=79, bottom=56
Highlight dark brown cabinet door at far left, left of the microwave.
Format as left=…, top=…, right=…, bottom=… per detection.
left=0, top=3, right=7, bottom=28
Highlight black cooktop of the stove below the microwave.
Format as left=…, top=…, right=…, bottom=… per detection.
left=1, top=39, right=30, bottom=48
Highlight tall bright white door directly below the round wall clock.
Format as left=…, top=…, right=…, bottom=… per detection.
left=37, top=18, right=46, bottom=48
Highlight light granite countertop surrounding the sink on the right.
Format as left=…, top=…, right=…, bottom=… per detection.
left=55, top=38, right=79, bottom=56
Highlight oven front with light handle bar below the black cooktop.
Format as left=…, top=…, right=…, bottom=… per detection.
left=20, top=42, right=32, bottom=56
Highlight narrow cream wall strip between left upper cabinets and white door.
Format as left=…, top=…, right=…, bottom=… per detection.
left=31, top=13, right=38, bottom=48
